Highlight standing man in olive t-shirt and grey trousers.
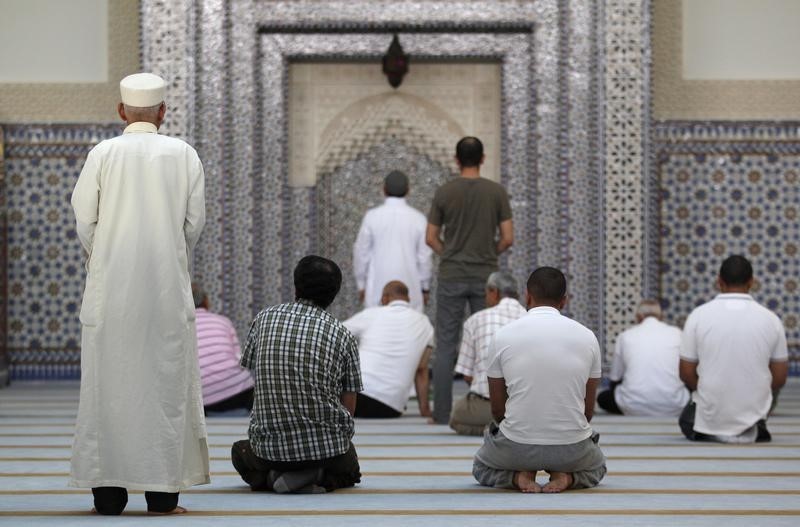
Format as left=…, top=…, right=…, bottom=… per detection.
left=425, top=137, right=514, bottom=424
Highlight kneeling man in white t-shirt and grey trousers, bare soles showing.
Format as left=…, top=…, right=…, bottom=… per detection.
left=472, top=267, right=606, bottom=493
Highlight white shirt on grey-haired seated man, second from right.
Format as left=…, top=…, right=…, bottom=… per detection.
left=609, top=317, right=689, bottom=416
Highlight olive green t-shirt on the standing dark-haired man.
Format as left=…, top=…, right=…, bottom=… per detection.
left=428, top=177, right=511, bottom=281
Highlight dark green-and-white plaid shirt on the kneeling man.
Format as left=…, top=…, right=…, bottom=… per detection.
left=241, top=300, right=363, bottom=461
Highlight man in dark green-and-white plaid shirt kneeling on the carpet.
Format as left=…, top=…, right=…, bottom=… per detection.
left=231, top=256, right=363, bottom=493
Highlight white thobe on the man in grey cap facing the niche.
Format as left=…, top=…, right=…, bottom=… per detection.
left=353, top=197, right=432, bottom=311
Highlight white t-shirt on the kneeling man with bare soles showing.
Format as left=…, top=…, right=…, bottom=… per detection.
left=487, top=307, right=601, bottom=445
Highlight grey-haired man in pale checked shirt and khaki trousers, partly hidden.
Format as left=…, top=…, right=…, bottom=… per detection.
left=450, top=271, right=526, bottom=436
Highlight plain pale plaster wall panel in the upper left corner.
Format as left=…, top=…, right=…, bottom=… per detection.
left=0, top=0, right=108, bottom=83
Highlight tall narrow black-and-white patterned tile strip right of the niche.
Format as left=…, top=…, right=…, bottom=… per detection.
left=602, top=0, right=650, bottom=361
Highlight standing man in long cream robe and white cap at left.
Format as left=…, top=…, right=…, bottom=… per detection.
left=70, top=73, right=210, bottom=515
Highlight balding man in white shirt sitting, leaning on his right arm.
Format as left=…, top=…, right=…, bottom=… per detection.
left=344, top=281, right=433, bottom=417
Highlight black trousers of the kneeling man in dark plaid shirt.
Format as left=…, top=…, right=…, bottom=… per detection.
left=231, top=439, right=361, bottom=492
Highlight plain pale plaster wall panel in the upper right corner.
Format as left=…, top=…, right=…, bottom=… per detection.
left=682, top=0, right=800, bottom=80
